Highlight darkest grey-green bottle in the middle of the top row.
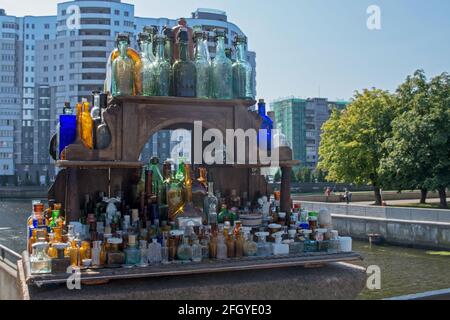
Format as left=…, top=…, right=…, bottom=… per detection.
left=173, top=29, right=197, bottom=97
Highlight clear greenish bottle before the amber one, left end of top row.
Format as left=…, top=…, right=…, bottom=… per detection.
left=112, top=34, right=135, bottom=96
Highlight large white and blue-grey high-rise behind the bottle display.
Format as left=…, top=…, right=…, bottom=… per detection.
left=0, top=0, right=256, bottom=184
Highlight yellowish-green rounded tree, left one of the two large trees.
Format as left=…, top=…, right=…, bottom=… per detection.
left=318, top=88, right=394, bottom=205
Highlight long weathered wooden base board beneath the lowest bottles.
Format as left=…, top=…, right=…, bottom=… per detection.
left=22, top=252, right=362, bottom=286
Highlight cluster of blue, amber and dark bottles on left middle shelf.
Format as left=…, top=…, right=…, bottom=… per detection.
left=50, top=91, right=111, bottom=160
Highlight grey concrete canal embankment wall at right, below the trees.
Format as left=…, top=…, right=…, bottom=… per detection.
left=302, top=202, right=450, bottom=250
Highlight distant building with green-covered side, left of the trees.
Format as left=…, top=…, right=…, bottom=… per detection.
left=271, top=97, right=348, bottom=169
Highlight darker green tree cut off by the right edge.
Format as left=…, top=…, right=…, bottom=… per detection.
left=381, top=70, right=450, bottom=208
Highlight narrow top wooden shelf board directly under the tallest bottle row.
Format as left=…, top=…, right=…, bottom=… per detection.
left=110, top=96, right=257, bottom=108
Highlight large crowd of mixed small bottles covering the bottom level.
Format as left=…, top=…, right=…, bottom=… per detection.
left=28, top=158, right=351, bottom=274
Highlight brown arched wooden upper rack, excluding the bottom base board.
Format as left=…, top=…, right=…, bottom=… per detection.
left=48, top=97, right=299, bottom=221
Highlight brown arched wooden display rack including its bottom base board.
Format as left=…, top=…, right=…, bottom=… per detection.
left=31, top=97, right=361, bottom=285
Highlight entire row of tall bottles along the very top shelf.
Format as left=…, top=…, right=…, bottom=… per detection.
left=105, top=20, right=255, bottom=99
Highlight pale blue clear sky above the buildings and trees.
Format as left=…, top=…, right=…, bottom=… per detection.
left=0, top=0, right=450, bottom=101
